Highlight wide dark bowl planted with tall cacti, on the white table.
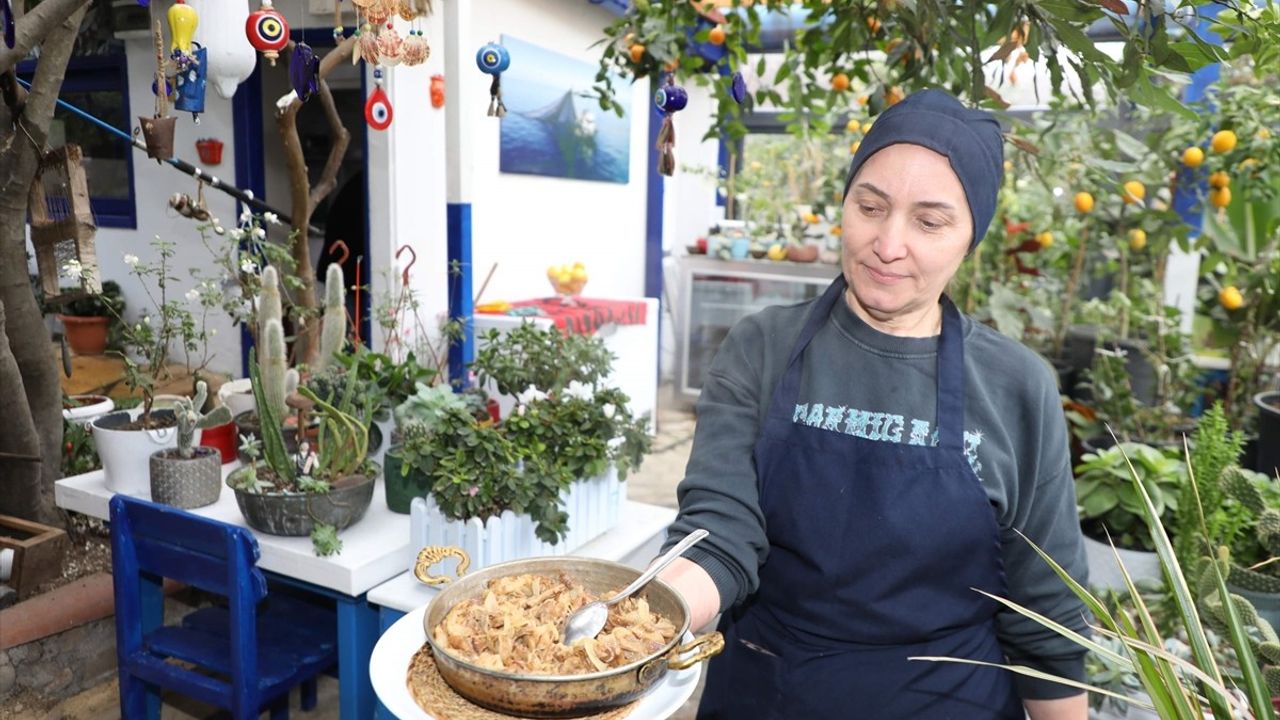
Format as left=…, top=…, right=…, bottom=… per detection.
left=227, top=340, right=378, bottom=555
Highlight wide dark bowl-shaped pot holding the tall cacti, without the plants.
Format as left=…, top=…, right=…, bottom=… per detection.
left=227, top=468, right=381, bottom=536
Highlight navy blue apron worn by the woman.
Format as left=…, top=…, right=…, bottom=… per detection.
left=698, top=277, right=1024, bottom=720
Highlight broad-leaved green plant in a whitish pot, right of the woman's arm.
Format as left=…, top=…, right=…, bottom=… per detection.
left=1075, top=442, right=1187, bottom=588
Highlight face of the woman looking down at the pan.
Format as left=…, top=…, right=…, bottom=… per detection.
left=842, top=145, right=973, bottom=323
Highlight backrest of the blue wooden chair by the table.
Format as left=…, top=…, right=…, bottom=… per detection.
left=110, top=495, right=266, bottom=606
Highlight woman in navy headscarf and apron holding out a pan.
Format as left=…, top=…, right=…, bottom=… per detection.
left=663, top=91, right=1087, bottom=720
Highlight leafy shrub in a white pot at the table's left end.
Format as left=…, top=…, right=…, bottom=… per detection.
left=92, top=238, right=207, bottom=497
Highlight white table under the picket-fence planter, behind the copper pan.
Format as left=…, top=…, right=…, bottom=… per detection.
left=367, top=501, right=675, bottom=720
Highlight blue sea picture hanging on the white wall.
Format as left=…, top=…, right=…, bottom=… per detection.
left=498, top=35, right=631, bottom=183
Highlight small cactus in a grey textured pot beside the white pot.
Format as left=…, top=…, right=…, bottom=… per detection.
left=151, top=380, right=230, bottom=509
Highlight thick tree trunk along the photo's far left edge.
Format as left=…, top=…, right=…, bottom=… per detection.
left=0, top=3, right=87, bottom=523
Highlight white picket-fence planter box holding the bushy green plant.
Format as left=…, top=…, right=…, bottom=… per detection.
left=406, top=468, right=627, bottom=570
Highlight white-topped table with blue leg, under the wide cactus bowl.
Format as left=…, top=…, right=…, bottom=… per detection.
left=54, top=462, right=410, bottom=720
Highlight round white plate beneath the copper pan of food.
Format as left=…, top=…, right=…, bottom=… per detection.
left=369, top=605, right=703, bottom=720
